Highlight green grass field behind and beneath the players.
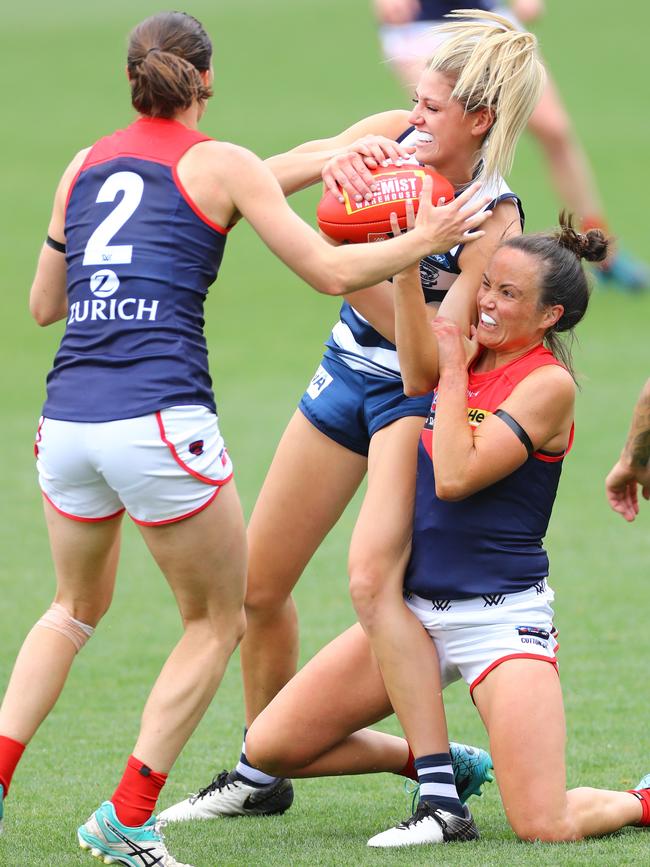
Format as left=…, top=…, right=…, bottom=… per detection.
left=0, top=0, right=650, bottom=867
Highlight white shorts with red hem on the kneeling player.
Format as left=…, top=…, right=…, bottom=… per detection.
left=404, top=580, right=559, bottom=695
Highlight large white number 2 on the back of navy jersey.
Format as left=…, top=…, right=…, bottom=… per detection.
left=83, top=172, right=144, bottom=265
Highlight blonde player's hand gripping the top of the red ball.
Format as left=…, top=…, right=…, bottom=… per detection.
left=322, top=135, right=415, bottom=202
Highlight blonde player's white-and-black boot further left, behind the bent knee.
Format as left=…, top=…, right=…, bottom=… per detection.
left=159, top=771, right=293, bottom=822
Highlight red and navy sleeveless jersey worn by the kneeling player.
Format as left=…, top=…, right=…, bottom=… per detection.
left=404, top=346, right=573, bottom=599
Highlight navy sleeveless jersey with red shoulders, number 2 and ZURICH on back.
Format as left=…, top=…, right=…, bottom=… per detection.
left=43, top=118, right=227, bottom=422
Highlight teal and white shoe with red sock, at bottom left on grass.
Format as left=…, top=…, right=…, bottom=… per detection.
left=77, top=801, right=192, bottom=867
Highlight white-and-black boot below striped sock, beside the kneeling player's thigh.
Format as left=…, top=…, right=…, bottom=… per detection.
left=368, top=801, right=479, bottom=848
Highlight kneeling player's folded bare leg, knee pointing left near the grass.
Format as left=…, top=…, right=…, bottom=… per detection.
left=246, top=624, right=408, bottom=777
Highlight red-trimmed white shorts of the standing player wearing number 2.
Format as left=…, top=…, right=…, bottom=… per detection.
left=34, top=406, right=232, bottom=526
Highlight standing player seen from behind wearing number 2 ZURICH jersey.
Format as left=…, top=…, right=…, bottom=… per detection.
left=0, top=12, right=484, bottom=867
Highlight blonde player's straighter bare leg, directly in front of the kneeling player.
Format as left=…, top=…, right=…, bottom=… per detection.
left=349, top=418, right=449, bottom=756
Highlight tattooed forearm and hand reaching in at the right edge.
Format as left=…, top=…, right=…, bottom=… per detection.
left=605, top=379, right=650, bottom=521
